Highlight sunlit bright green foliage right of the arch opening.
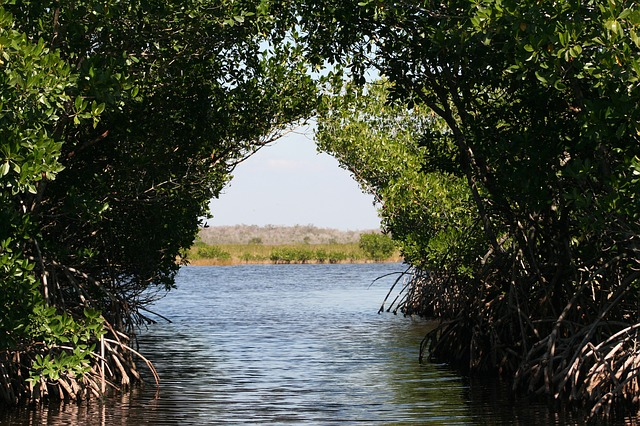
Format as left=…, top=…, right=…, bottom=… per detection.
left=316, top=80, right=477, bottom=268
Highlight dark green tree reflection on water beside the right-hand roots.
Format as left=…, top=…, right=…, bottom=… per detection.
left=376, top=319, right=596, bottom=426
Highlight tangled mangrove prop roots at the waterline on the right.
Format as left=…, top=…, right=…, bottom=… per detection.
left=395, top=253, right=640, bottom=417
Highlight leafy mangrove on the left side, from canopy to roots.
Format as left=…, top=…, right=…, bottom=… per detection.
left=0, top=0, right=317, bottom=401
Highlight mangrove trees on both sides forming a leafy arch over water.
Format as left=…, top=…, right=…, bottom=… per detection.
left=0, top=0, right=640, bottom=420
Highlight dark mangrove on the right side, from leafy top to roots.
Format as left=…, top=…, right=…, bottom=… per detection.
left=301, top=0, right=640, bottom=413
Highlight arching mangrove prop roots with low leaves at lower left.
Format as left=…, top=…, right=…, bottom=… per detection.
left=0, top=246, right=170, bottom=405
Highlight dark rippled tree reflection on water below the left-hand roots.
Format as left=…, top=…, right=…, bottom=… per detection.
left=0, top=324, right=226, bottom=426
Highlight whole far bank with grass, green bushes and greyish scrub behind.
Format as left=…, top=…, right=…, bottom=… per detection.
left=187, top=225, right=402, bottom=266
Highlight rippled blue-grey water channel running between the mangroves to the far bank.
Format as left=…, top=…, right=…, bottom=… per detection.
left=0, top=264, right=632, bottom=425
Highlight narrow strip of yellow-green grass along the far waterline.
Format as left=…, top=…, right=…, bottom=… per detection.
left=187, top=242, right=402, bottom=266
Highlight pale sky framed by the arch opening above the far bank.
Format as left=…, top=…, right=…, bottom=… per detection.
left=208, top=129, right=380, bottom=230
